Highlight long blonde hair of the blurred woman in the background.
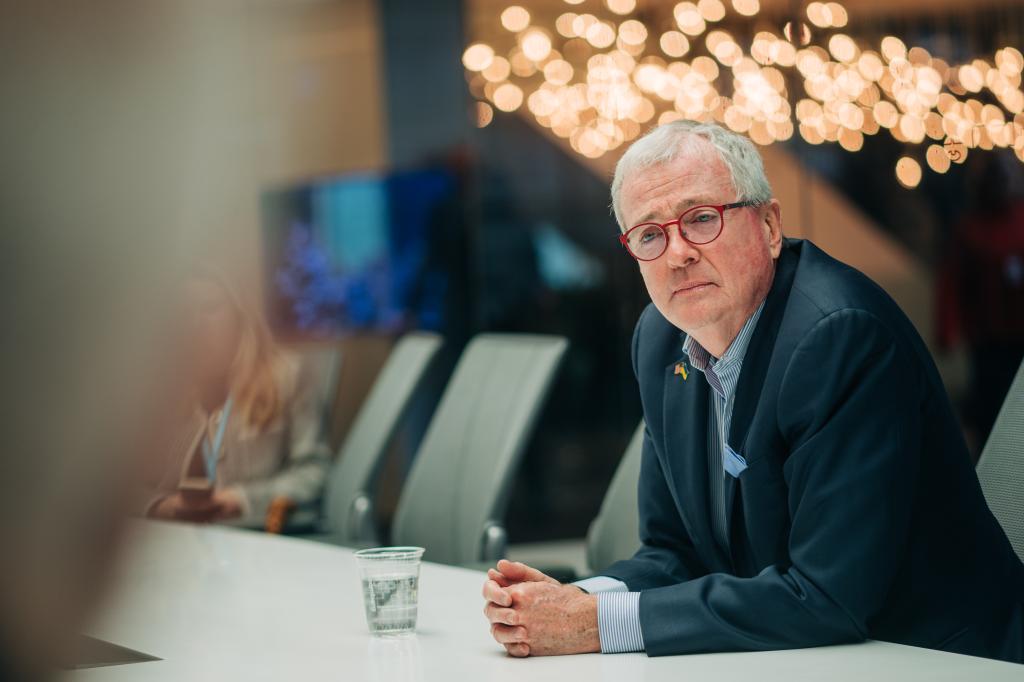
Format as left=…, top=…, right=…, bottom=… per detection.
left=189, top=263, right=294, bottom=431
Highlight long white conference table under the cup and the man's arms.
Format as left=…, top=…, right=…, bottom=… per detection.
left=67, top=521, right=1024, bottom=682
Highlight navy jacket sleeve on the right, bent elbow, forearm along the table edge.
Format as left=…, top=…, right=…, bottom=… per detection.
left=640, top=309, right=925, bottom=655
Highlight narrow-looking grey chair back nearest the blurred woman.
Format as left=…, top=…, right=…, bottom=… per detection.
left=323, top=332, right=441, bottom=545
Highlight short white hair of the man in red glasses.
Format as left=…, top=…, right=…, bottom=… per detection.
left=611, top=119, right=772, bottom=230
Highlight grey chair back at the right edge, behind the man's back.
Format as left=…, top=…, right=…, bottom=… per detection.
left=978, top=352, right=1024, bottom=561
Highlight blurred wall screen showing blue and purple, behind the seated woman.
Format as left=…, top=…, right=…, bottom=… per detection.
left=262, top=169, right=456, bottom=336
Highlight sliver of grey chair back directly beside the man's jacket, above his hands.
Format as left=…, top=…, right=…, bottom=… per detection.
left=587, top=421, right=644, bottom=572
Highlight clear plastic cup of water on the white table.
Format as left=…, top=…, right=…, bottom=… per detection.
left=355, top=547, right=423, bottom=636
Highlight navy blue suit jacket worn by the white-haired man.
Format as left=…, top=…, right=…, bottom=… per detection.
left=602, top=240, right=1024, bottom=662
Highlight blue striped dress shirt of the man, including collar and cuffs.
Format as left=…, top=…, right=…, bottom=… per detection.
left=575, top=301, right=764, bottom=653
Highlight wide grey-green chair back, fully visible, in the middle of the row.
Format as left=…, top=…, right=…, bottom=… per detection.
left=391, top=334, right=568, bottom=564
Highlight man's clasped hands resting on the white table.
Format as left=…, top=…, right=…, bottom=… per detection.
left=483, top=559, right=601, bottom=656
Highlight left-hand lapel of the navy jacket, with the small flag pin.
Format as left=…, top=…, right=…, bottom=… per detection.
left=663, top=346, right=725, bottom=564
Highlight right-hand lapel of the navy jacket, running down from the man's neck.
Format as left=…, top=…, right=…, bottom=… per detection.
left=725, top=241, right=799, bottom=545
